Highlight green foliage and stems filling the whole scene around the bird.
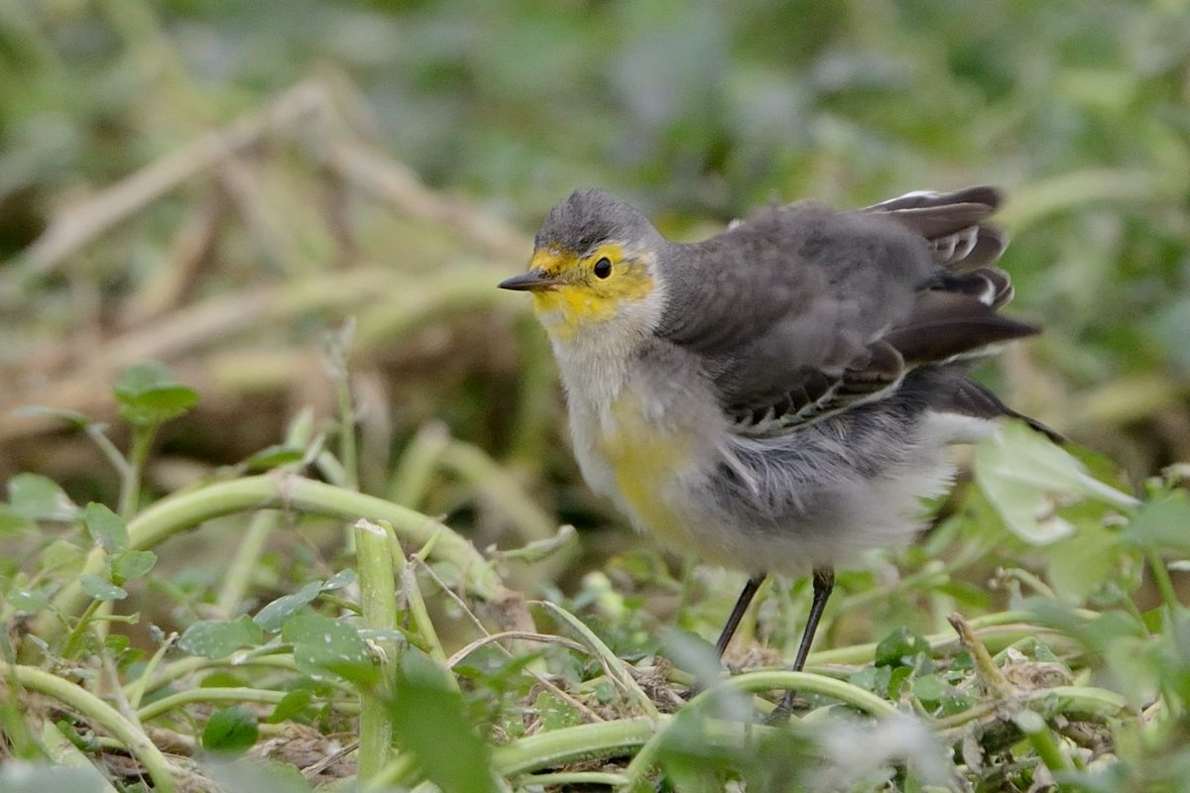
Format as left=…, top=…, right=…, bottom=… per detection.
left=0, top=0, right=1190, bottom=793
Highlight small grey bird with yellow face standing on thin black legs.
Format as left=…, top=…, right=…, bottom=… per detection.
left=499, top=186, right=1060, bottom=719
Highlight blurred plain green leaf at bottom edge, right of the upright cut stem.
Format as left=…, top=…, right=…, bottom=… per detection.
left=389, top=648, right=496, bottom=793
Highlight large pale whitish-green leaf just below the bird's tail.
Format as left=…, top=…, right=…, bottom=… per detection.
left=975, top=422, right=1138, bottom=545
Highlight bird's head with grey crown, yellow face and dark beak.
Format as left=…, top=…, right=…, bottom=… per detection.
left=500, top=189, right=668, bottom=342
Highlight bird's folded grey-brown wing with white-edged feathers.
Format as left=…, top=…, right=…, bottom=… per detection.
left=656, top=187, right=1036, bottom=433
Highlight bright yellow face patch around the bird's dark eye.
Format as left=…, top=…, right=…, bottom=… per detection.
left=511, top=243, right=653, bottom=338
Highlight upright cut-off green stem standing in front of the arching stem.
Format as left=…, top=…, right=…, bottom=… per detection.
left=355, top=520, right=396, bottom=783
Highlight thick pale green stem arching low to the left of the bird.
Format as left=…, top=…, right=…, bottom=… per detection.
left=35, top=474, right=505, bottom=637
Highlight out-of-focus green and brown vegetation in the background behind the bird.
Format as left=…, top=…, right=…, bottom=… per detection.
left=0, top=0, right=1190, bottom=511
